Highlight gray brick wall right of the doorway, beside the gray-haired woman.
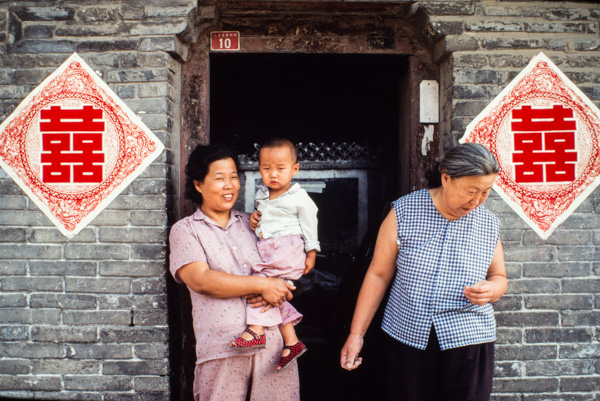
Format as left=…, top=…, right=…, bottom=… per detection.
left=432, top=1, right=600, bottom=401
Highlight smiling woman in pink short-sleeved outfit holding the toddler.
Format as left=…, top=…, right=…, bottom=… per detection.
left=169, top=145, right=300, bottom=401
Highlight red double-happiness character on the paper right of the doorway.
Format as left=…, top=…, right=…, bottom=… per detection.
left=511, top=105, right=577, bottom=183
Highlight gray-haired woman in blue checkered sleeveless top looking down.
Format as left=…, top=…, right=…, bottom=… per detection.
left=340, top=143, right=507, bottom=401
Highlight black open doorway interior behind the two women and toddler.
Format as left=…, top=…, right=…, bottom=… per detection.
left=210, top=53, right=408, bottom=401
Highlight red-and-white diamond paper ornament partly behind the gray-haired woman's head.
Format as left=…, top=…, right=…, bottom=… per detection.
left=460, top=53, right=600, bottom=239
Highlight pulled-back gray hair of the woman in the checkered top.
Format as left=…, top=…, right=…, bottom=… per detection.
left=427, top=142, right=500, bottom=188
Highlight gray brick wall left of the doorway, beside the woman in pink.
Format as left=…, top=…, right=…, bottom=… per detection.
left=0, top=1, right=194, bottom=400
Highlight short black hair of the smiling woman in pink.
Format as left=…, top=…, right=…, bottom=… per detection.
left=185, top=143, right=239, bottom=205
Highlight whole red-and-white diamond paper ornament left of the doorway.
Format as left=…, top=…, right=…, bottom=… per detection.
left=0, top=53, right=164, bottom=238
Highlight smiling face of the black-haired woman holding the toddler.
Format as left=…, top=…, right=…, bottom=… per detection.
left=194, top=158, right=240, bottom=212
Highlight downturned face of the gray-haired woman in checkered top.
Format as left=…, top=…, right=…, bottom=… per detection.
left=442, top=174, right=496, bottom=219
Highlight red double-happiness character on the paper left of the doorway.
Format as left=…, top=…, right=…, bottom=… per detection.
left=40, top=106, right=104, bottom=183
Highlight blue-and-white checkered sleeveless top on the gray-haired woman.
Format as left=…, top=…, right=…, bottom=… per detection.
left=382, top=189, right=500, bottom=350
